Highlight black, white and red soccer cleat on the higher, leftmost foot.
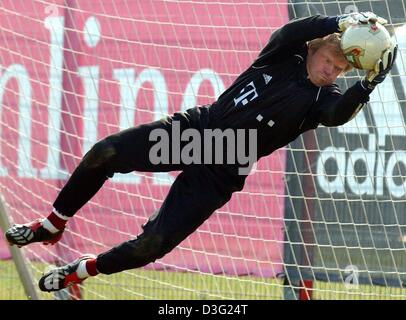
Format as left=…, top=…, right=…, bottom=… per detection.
left=5, top=219, right=63, bottom=247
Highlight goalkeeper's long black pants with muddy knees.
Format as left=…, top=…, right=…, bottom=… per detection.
left=54, top=107, right=242, bottom=274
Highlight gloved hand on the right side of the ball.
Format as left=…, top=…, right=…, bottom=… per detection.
left=361, top=44, right=398, bottom=90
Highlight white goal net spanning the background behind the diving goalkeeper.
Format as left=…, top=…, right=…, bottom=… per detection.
left=0, top=0, right=406, bottom=299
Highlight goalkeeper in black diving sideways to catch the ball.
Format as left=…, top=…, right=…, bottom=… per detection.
left=5, top=12, right=397, bottom=292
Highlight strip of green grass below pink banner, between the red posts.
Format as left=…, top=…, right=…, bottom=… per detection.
left=85, top=270, right=282, bottom=300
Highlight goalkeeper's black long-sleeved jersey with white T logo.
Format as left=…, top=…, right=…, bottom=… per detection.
left=210, top=15, right=371, bottom=159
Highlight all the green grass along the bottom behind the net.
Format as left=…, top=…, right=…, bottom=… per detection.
left=0, top=261, right=406, bottom=300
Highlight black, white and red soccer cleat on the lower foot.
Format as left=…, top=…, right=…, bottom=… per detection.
left=38, top=254, right=96, bottom=292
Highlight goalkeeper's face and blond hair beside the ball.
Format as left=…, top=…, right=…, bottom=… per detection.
left=306, top=45, right=348, bottom=87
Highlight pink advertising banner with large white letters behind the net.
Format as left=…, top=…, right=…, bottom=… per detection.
left=0, top=0, right=288, bottom=276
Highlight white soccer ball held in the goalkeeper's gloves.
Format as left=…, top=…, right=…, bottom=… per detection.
left=341, top=23, right=392, bottom=70
